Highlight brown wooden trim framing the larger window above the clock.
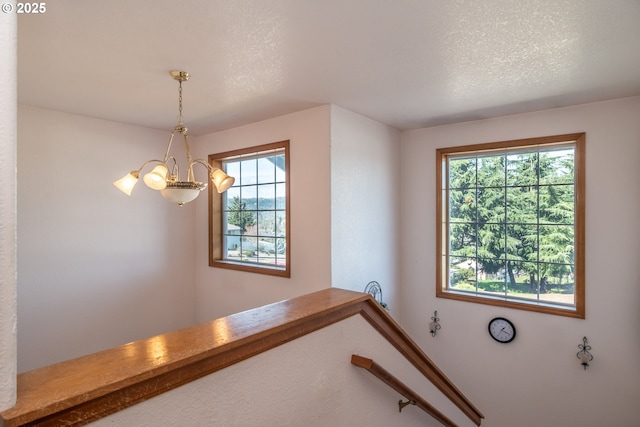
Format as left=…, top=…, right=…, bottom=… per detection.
left=436, top=133, right=586, bottom=319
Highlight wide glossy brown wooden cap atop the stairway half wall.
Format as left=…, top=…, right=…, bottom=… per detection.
left=0, top=288, right=483, bottom=427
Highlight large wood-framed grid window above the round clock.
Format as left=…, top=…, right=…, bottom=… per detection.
left=436, top=133, right=585, bottom=318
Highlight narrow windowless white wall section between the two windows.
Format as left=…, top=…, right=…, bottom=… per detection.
left=331, top=106, right=400, bottom=312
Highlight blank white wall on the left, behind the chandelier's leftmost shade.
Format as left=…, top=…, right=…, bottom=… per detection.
left=17, top=106, right=195, bottom=371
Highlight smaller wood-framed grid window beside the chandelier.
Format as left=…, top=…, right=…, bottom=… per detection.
left=209, top=141, right=291, bottom=277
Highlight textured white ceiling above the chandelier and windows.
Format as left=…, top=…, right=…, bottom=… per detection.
left=18, top=0, right=640, bottom=134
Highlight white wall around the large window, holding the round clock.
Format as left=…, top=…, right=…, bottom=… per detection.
left=400, top=97, right=640, bottom=427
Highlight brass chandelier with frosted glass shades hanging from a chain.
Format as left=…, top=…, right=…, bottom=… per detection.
left=113, top=71, right=235, bottom=206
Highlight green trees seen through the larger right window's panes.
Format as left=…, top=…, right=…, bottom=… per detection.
left=448, top=147, right=574, bottom=294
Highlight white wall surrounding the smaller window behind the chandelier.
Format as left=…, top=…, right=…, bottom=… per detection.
left=192, top=105, right=331, bottom=321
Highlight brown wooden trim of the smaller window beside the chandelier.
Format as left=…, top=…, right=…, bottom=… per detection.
left=208, top=140, right=291, bottom=277
